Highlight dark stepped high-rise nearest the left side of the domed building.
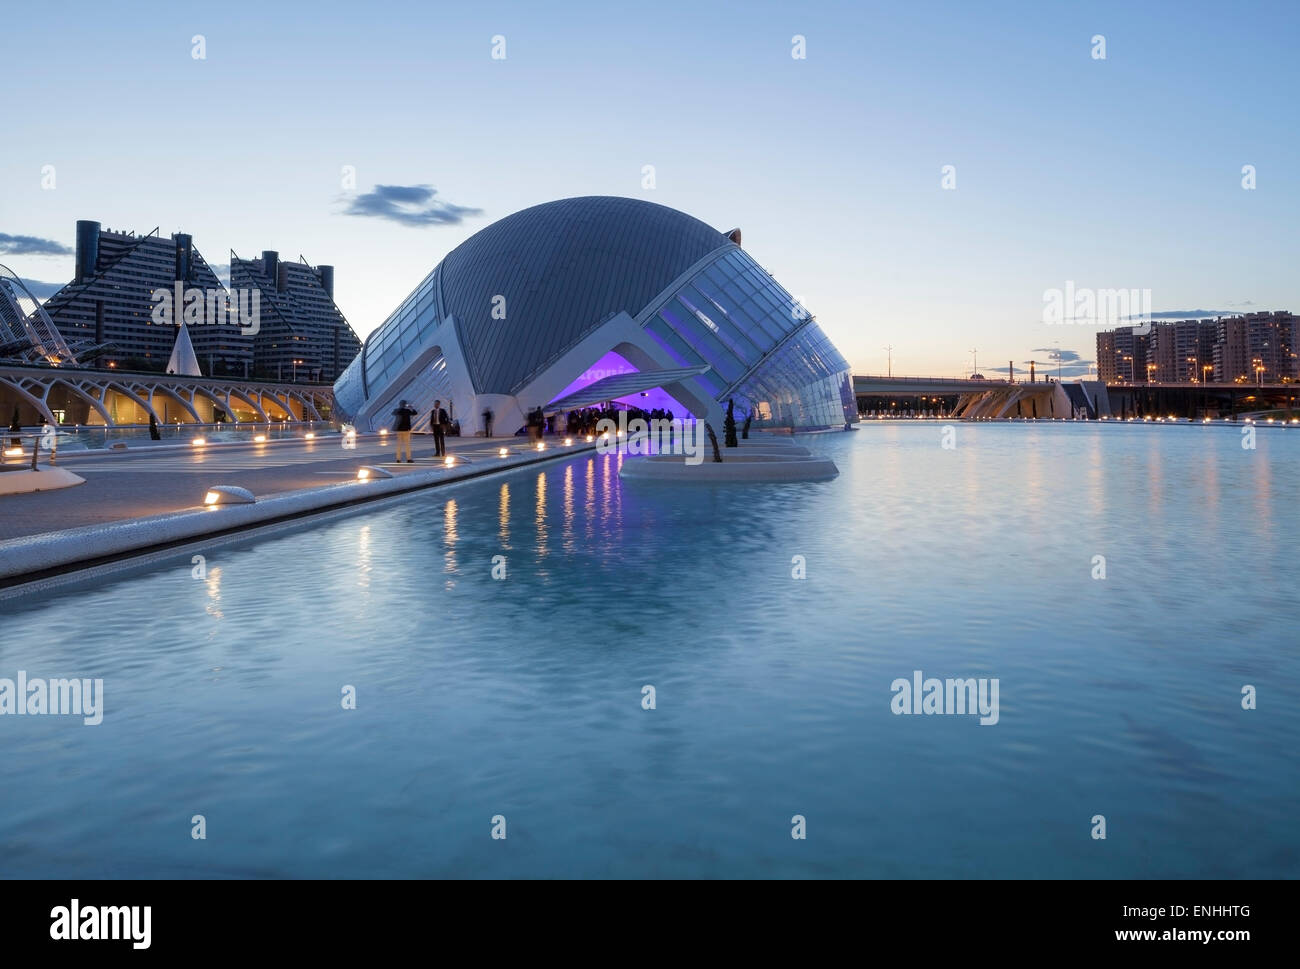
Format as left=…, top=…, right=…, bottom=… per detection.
left=230, top=250, right=361, bottom=382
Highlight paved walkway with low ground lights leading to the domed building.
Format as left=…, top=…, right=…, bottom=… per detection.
left=0, top=434, right=554, bottom=541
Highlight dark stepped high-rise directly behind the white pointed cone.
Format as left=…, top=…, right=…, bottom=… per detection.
left=44, top=220, right=252, bottom=377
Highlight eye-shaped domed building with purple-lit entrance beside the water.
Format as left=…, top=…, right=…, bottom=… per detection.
left=334, top=196, right=857, bottom=434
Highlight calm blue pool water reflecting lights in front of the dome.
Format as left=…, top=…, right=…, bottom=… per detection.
left=0, top=423, right=1300, bottom=878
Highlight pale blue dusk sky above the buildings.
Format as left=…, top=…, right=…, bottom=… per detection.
left=0, top=0, right=1300, bottom=373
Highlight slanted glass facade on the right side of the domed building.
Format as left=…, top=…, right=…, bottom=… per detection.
left=642, top=248, right=857, bottom=428
